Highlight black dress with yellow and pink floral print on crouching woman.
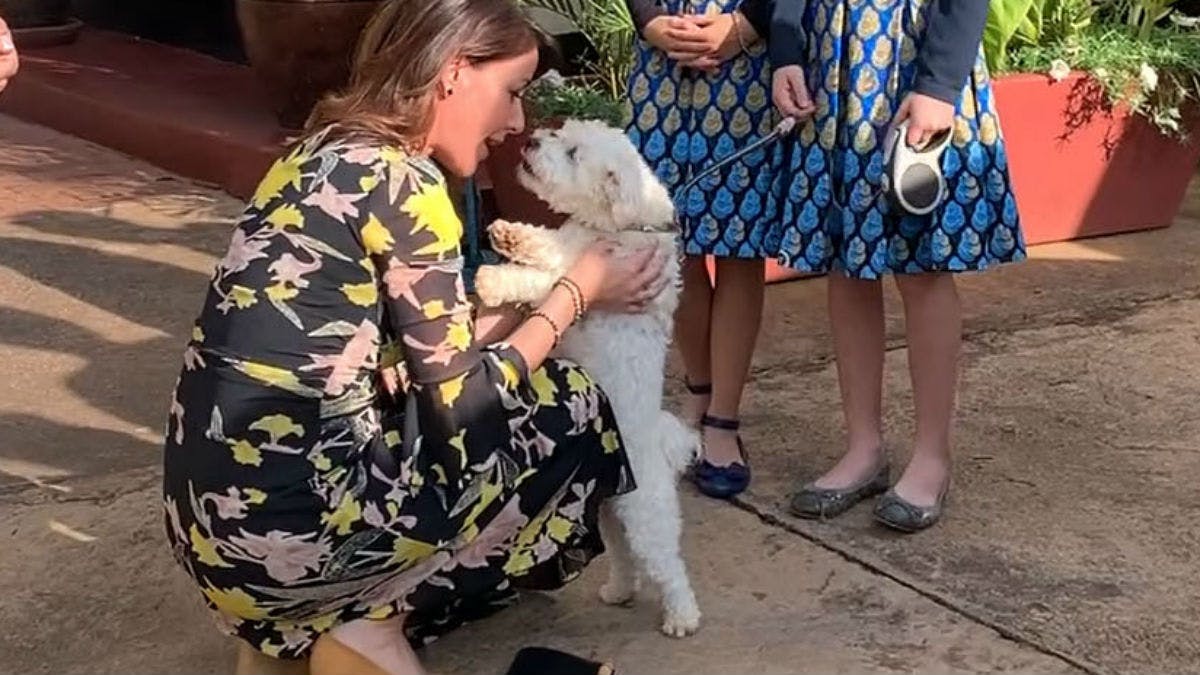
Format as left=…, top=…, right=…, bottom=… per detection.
left=163, top=131, right=634, bottom=658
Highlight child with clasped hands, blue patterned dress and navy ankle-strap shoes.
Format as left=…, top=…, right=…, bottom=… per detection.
left=626, top=0, right=774, bottom=498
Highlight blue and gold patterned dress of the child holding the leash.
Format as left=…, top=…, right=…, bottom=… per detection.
left=768, top=0, right=1025, bottom=279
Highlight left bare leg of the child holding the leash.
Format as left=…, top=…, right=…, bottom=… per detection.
left=816, top=271, right=883, bottom=489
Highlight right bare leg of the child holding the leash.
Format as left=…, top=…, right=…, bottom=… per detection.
left=895, top=274, right=962, bottom=506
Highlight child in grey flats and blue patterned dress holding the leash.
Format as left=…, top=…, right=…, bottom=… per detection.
left=770, top=0, right=1025, bottom=532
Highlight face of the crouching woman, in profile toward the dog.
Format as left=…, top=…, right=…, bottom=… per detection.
left=427, top=49, right=538, bottom=177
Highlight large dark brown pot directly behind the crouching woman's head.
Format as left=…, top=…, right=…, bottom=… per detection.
left=238, top=0, right=379, bottom=129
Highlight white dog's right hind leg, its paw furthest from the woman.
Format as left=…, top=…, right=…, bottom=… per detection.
left=616, top=480, right=700, bottom=638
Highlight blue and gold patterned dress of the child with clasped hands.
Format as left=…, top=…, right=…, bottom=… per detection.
left=628, top=0, right=774, bottom=258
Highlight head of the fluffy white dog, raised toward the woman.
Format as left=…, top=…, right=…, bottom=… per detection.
left=518, top=120, right=674, bottom=232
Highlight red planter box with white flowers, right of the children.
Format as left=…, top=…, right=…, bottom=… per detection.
left=995, top=73, right=1200, bottom=244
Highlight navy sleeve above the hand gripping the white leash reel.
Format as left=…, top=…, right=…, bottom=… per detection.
left=913, top=0, right=988, bottom=104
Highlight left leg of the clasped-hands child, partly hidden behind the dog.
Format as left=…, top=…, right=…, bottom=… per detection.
left=674, top=256, right=713, bottom=424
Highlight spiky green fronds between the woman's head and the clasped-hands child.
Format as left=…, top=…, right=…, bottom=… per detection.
left=523, top=0, right=637, bottom=100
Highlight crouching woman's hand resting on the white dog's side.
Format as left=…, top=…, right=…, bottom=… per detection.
left=568, top=241, right=671, bottom=313
